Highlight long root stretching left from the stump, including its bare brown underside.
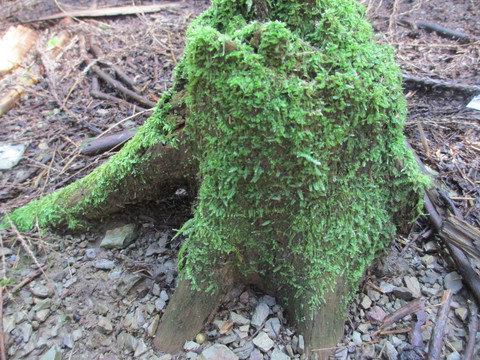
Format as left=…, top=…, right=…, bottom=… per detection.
left=4, top=138, right=195, bottom=231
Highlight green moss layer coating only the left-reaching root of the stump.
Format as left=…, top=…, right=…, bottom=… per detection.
left=0, top=90, right=181, bottom=231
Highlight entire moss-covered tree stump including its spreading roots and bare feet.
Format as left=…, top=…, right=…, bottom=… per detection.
left=4, top=0, right=423, bottom=358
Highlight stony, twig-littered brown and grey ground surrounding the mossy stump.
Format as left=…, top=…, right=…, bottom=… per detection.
left=0, top=0, right=480, bottom=360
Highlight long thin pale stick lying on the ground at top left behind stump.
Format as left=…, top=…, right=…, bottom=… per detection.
left=25, top=1, right=184, bottom=23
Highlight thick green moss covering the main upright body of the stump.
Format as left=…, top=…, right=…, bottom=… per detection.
left=178, top=0, right=424, bottom=306
